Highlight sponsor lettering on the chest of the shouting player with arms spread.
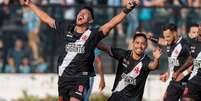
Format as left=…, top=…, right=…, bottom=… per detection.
left=65, top=43, right=85, bottom=53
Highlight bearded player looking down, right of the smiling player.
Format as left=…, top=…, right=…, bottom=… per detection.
left=161, top=24, right=191, bottom=101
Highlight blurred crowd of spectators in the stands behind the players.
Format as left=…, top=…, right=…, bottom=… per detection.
left=0, top=0, right=201, bottom=73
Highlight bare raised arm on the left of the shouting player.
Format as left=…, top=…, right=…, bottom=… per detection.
left=24, top=0, right=56, bottom=28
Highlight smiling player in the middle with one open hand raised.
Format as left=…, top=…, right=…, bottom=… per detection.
left=99, top=33, right=161, bottom=101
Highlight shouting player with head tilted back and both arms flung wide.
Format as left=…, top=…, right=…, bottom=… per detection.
left=25, top=0, right=139, bottom=101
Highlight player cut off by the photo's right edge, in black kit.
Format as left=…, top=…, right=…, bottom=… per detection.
left=183, top=24, right=201, bottom=101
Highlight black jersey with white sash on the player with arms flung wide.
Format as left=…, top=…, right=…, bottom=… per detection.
left=52, top=21, right=104, bottom=78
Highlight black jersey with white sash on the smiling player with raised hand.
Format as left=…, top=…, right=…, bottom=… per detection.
left=111, top=48, right=151, bottom=101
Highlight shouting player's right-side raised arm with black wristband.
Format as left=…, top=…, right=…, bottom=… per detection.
left=100, top=0, right=140, bottom=36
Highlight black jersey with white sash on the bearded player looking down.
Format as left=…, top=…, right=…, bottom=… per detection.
left=167, top=37, right=190, bottom=82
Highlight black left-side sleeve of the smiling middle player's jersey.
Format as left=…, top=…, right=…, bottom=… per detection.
left=110, top=48, right=128, bottom=60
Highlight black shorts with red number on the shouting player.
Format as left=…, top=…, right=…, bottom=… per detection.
left=58, top=78, right=89, bottom=101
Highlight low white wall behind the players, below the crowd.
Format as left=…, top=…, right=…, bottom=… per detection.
left=0, top=74, right=170, bottom=101
